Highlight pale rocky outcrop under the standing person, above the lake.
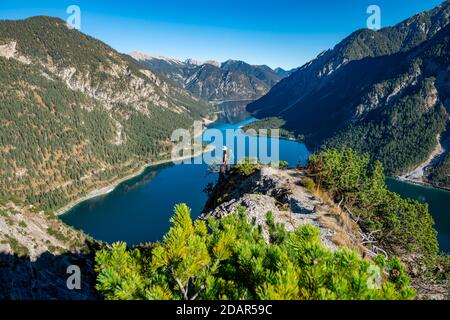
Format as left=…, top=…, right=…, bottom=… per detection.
left=200, top=167, right=365, bottom=254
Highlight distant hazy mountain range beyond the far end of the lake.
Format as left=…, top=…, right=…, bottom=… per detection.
left=130, top=52, right=290, bottom=103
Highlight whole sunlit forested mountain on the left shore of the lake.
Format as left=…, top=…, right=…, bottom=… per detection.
left=0, top=17, right=210, bottom=210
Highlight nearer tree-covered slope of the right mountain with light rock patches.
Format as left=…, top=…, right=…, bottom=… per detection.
left=324, top=21, right=450, bottom=174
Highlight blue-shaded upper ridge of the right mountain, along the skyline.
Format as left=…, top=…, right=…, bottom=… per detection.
left=248, top=1, right=450, bottom=117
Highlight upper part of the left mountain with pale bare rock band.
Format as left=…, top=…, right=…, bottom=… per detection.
left=0, top=17, right=207, bottom=115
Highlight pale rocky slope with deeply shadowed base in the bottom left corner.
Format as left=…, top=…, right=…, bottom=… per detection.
left=0, top=203, right=101, bottom=300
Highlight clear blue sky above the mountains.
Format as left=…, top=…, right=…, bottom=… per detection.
left=0, top=0, right=442, bottom=68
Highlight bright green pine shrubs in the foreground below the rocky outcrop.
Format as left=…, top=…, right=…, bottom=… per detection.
left=96, top=205, right=414, bottom=300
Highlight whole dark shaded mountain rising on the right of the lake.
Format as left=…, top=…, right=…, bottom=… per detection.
left=248, top=1, right=450, bottom=186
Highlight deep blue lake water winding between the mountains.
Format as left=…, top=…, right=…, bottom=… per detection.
left=61, top=119, right=450, bottom=252
